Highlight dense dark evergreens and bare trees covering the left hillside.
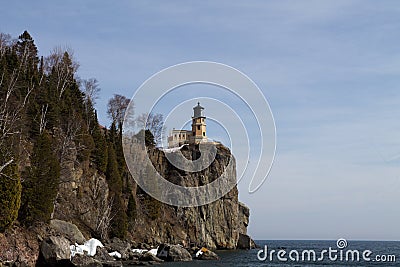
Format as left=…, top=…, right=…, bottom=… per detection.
left=0, top=31, right=165, bottom=238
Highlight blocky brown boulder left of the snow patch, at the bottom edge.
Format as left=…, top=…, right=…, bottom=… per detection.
left=40, top=236, right=71, bottom=265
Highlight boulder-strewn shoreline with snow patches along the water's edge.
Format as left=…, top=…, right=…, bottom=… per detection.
left=0, top=220, right=254, bottom=267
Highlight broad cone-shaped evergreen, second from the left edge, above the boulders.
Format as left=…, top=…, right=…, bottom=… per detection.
left=19, top=132, right=60, bottom=224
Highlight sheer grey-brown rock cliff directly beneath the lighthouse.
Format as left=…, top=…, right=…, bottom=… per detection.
left=128, top=145, right=249, bottom=249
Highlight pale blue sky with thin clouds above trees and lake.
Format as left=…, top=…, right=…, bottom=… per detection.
left=0, top=0, right=400, bottom=240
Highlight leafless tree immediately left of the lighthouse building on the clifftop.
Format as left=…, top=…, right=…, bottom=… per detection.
left=136, top=113, right=166, bottom=145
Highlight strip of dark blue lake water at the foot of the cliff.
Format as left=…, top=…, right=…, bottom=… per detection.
left=160, top=240, right=400, bottom=267
